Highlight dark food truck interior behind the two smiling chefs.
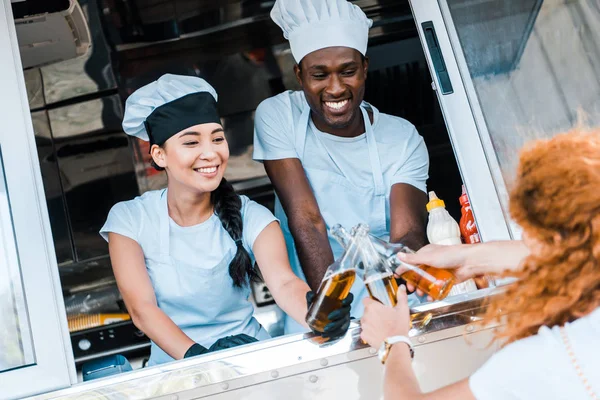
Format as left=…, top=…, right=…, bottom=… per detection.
left=13, top=0, right=462, bottom=376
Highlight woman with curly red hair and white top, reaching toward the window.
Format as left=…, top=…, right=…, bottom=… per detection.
left=361, top=130, right=600, bottom=400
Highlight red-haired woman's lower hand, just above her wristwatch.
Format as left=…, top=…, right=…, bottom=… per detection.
left=360, top=285, right=410, bottom=348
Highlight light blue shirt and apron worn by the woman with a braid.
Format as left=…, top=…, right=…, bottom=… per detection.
left=100, top=190, right=276, bottom=365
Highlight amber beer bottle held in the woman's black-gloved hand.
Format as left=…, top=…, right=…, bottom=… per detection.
left=306, top=227, right=359, bottom=333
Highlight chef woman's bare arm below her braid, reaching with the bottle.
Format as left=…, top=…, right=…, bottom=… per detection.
left=252, top=221, right=310, bottom=327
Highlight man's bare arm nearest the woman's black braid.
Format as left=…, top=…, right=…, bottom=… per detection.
left=264, top=158, right=333, bottom=291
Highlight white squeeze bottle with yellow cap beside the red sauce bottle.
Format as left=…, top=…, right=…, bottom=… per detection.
left=427, top=191, right=477, bottom=296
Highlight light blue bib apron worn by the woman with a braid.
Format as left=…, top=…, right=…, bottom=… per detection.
left=146, top=190, right=270, bottom=366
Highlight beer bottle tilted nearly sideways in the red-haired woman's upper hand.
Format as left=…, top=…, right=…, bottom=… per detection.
left=369, top=235, right=456, bottom=300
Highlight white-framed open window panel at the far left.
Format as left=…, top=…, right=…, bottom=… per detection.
left=0, top=2, right=75, bottom=399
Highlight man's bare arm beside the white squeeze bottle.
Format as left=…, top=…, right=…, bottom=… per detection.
left=390, top=183, right=427, bottom=250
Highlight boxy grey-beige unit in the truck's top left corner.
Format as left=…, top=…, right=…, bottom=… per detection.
left=12, top=0, right=92, bottom=68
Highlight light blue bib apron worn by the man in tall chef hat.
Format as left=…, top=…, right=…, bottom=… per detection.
left=275, top=103, right=389, bottom=334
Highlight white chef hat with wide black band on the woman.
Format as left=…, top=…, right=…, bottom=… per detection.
left=123, top=74, right=221, bottom=145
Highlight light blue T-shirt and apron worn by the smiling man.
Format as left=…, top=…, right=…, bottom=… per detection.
left=254, top=91, right=429, bottom=333
